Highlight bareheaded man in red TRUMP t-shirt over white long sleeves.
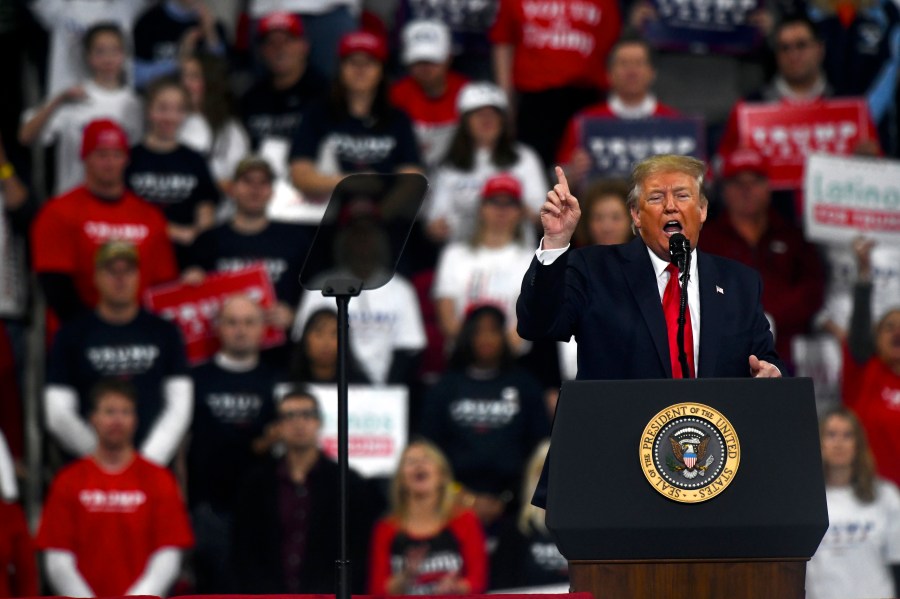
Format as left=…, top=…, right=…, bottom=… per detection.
left=37, top=379, right=194, bottom=597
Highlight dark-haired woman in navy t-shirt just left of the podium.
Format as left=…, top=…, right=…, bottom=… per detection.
left=421, top=305, right=550, bottom=526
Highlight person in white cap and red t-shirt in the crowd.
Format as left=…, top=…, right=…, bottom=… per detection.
left=391, top=20, right=467, bottom=168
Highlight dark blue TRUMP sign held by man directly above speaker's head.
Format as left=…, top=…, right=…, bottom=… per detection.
left=581, top=117, right=706, bottom=179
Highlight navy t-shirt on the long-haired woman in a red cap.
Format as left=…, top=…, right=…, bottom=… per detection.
left=291, top=103, right=422, bottom=174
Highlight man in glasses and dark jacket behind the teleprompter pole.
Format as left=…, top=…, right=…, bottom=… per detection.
left=233, top=389, right=384, bottom=594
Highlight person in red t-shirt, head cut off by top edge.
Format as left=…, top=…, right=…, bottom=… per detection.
left=490, top=0, right=622, bottom=166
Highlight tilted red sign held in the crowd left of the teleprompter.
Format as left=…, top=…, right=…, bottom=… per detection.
left=144, top=265, right=285, bottom=364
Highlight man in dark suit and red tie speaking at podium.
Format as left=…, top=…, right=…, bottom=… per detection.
left=516, top=155, right=783, bottom=379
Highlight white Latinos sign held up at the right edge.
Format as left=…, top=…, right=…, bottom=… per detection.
left=803, top=154, right=900, bottom=245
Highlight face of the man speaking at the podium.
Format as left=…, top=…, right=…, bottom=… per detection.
left=631, top=171, right=706, bottom=262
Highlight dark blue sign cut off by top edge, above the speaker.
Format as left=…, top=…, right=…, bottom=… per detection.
left=644, top=0, right=762, bottom=55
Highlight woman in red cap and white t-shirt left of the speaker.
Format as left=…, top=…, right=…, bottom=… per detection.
left=432, top=174, right=534, bottom=353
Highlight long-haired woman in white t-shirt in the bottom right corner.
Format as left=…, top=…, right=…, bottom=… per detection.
left=806, top=407, right=900, bottom=599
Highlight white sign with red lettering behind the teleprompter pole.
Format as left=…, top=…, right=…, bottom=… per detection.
left=309, top=385, right=409, bottom=477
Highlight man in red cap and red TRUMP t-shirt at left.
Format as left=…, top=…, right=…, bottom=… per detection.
left=31, top=119, right=178, bottom=320
